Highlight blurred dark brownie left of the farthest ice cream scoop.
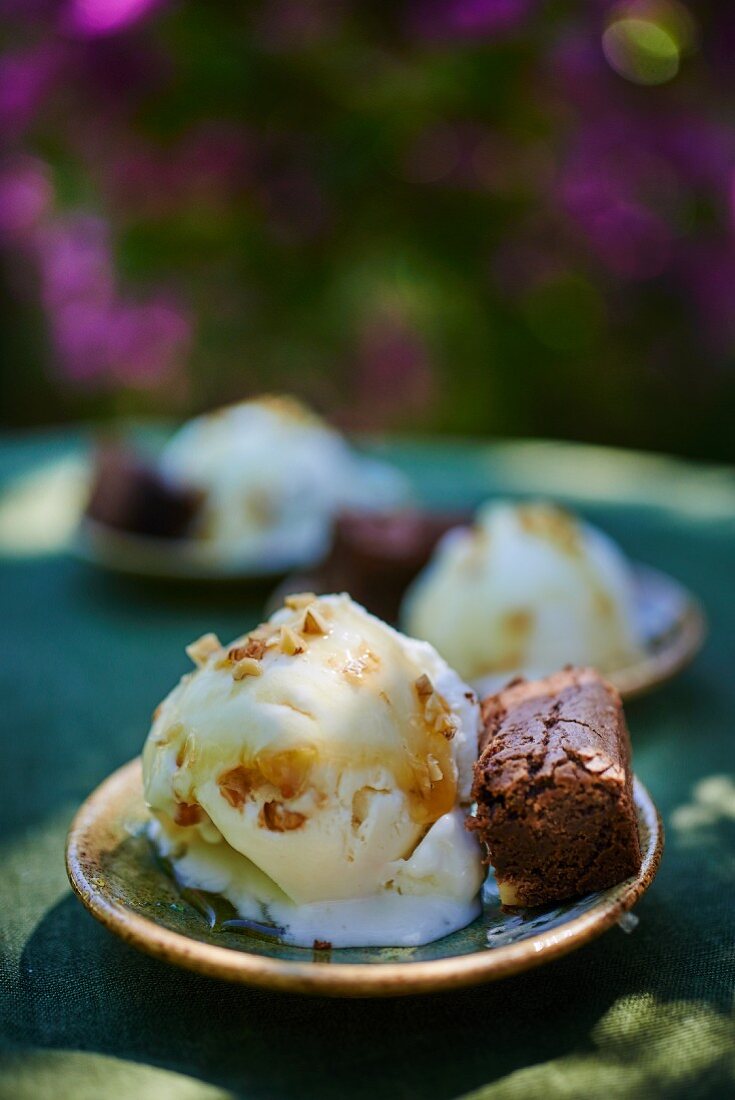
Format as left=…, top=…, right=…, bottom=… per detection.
left=87, top=444, right=201, bottom=539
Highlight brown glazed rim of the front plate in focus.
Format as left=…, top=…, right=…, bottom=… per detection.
left=66, top=757, right=663, bottom=997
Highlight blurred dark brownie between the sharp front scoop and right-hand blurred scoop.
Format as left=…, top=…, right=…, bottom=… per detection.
left=319, top=509, right=471, bottom=622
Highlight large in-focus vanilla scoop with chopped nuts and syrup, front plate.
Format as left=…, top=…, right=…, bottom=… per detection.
left=143, top=595, right=483, bottom=946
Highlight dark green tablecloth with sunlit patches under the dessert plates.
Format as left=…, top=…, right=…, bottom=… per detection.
left=0, top=433, right=735, bottom=1100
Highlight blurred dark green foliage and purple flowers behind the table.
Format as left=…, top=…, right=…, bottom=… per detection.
left=0, top=0, right=735, bottom=459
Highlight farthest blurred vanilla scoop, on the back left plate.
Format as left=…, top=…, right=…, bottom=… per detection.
left=161, top=397, right=407, bottom=562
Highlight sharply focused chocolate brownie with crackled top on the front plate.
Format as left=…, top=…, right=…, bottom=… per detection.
left=469, top=669, right=640, bottom=905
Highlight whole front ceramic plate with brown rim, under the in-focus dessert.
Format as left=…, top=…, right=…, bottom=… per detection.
left=66, top=759, right=663, bottom=997
